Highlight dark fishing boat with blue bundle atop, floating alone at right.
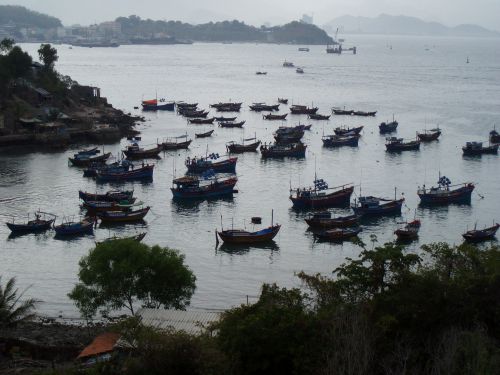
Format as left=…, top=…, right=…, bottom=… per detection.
left=417, top=175, right=475, bottom=204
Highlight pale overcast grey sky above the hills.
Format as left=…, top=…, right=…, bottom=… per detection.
left=0, top=0, right=500, bottom=30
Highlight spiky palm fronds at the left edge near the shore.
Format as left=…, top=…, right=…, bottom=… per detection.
left=0, top=276, right=39, bottom=327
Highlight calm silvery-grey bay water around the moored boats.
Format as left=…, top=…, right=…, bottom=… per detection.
left=0, top=37, right=500, bottom=317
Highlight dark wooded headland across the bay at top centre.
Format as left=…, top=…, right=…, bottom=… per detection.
left=116, top=16, right=332, bottom=44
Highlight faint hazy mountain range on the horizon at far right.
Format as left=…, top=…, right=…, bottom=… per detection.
left=323, top=14, right=500, bottom=37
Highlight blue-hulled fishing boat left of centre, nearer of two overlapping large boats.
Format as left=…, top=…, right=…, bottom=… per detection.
left=170, top=169, right=238, bottom=199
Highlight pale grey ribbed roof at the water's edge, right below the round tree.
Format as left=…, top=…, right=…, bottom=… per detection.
left=137, top=309, right=221, bottom=335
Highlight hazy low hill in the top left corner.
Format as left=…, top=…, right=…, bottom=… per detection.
left=0, top=5, right=62, bottom=29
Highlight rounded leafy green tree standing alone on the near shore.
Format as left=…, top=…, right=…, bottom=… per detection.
left=68, top=240, right=196, bottom=319
